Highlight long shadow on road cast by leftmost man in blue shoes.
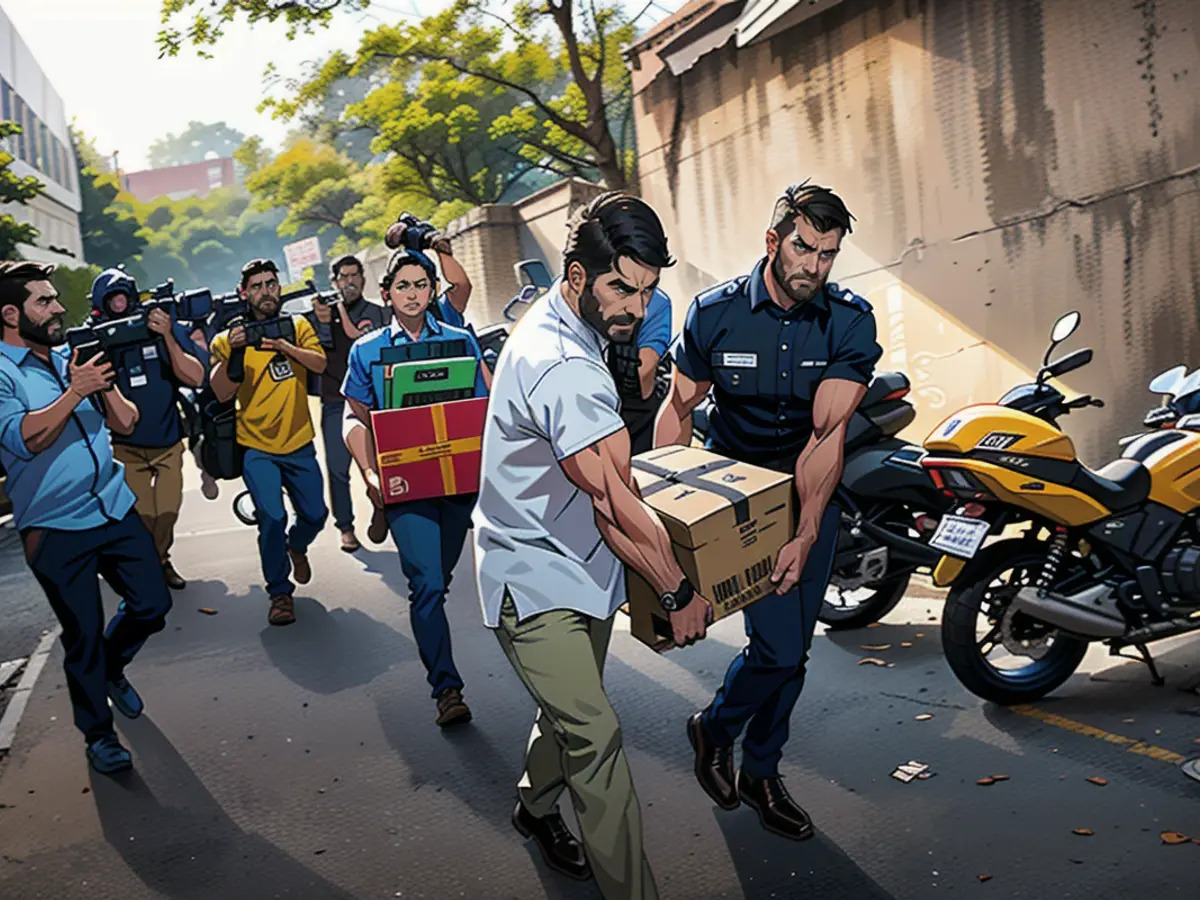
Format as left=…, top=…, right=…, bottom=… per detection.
left=91, top=716, right=355, bottom=900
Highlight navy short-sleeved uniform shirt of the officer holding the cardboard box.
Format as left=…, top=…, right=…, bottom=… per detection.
left=673, top=259, right=882, bottom=470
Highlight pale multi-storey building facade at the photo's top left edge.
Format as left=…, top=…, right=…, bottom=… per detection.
left=0, top=4, right=84, bottom=266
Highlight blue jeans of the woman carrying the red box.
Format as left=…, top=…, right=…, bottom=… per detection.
left=386, top=494, right=475, bottom=697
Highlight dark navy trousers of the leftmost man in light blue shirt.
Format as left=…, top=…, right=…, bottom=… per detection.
left=23, top=510, right=170, bottom=744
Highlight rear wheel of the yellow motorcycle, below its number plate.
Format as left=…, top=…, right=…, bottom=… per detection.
left=942, top=540, right=1087, bottom=706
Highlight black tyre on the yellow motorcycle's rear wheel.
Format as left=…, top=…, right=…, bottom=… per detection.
left=942, top=539, right=1087, bottom=706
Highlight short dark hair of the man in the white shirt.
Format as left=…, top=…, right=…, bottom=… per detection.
left=563, top=191, right=674, bottom=284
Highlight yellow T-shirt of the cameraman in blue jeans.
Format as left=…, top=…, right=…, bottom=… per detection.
left=211, top=316, right=325, bottom=456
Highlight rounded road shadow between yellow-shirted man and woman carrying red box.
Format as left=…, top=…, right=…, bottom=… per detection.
left=259, top=596, right=418, bottom=694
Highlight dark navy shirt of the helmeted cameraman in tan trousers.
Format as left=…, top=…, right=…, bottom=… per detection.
left=109, top=322, right=209, bottom=449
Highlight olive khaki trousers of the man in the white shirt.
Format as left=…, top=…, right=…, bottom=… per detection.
left=496, top=594, right=659, bottom=900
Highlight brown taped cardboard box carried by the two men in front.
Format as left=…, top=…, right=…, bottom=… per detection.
left=628, top=446, right=796, bottom=652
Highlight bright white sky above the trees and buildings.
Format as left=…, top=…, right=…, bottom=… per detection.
left=0, top=0, right=683, bottom=172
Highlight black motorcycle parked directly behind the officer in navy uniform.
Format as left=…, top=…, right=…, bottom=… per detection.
left=692, top=372, right=954, bottom=630
